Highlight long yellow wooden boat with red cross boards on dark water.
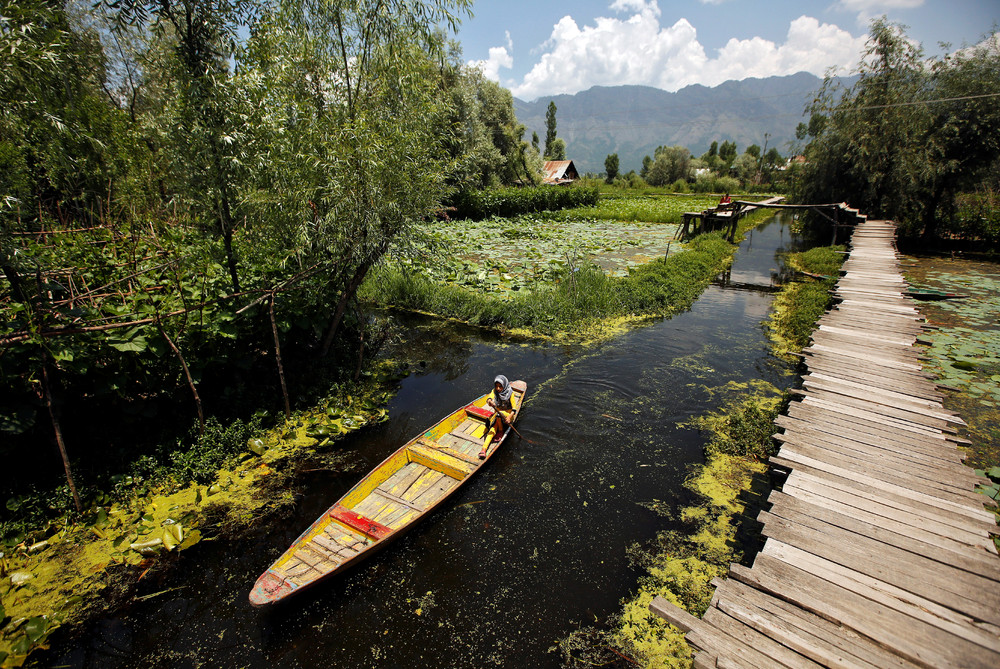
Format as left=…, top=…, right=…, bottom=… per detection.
left=250, top=381, right=528, bottom=606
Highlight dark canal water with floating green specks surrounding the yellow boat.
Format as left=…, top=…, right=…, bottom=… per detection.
left=45, top=218, right=798, bottom=668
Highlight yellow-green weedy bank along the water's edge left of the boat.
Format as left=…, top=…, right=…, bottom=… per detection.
left=0, top=365, right=398, bottom=667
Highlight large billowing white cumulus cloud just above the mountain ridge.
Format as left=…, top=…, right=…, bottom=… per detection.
left=508, top=0, right=868, bottom=100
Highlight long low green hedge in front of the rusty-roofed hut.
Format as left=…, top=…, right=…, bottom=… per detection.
left=449, top=186, right=598, bottom=221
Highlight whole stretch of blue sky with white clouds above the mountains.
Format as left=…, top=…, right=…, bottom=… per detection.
left=458, top=0, right=1000, bottom=101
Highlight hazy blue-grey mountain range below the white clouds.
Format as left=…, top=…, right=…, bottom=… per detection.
left=514, top=72, right=852, bottom=173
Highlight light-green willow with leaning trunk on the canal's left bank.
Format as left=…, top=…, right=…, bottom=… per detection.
left=238, top=0, right=471, bottom=355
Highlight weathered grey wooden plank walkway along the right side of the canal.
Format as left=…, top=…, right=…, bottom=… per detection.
left=650, top=221, right=1000, bottom=668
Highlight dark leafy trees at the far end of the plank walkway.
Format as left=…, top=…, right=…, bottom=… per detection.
left=792, top=18, right=1000, bottom=245
